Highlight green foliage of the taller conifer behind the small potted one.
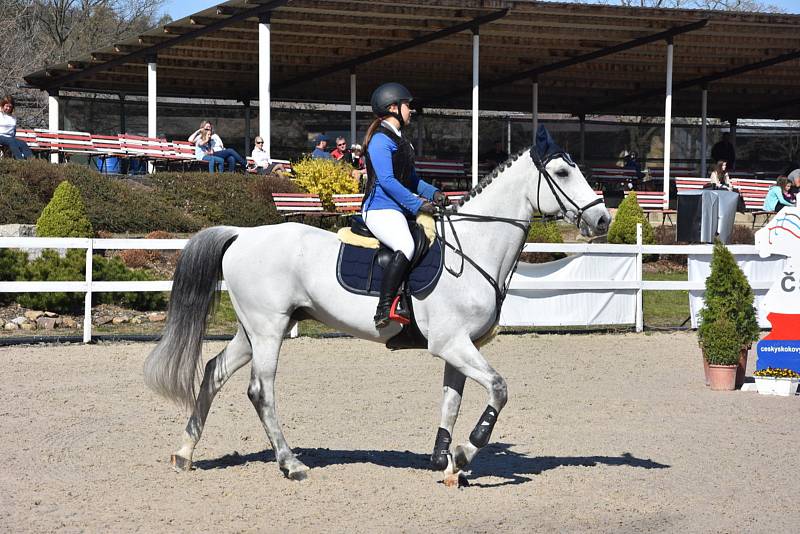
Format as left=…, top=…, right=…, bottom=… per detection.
left=697, top=241, right=759, bottom=347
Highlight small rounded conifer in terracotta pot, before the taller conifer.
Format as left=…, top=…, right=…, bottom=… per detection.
left=700, top=317, right=742, bottom=391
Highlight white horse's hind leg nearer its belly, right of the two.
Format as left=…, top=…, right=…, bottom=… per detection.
left=247, top=316, right=308, bottom=480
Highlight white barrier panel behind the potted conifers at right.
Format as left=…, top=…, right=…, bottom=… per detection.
left=689, top=254, right=786, bottom=328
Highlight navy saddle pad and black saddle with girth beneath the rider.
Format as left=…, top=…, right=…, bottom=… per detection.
left=336, top=215, right=444, bottom=350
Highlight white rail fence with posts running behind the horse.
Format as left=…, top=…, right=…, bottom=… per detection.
left=0, top=226, right=773, bottom=343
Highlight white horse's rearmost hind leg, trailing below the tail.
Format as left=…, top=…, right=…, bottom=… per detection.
left=171, top=326, right=252, bottom=470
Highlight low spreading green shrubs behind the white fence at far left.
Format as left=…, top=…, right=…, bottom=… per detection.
left=16, top=249, right=166, bottom=313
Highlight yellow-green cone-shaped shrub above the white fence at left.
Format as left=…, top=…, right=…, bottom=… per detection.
left=36, top=181, right=94, bottom=237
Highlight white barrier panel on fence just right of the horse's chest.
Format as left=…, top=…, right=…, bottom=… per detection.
left=500, top=253, right=639, bottom=326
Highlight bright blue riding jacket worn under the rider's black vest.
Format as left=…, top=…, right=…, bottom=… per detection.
left=364, top=121, right=438, bottom=216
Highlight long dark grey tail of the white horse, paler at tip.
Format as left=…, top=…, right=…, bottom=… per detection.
left=144, top=226, right=239, bottom=407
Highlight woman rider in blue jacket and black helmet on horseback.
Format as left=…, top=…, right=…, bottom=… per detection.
left=362, top=83, right=445, bottom=328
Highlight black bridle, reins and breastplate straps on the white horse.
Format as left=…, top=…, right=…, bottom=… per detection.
left=436, top=147, right=603, bottom=324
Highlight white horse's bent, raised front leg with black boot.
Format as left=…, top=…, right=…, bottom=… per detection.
left=441, top=337, right=508, bottom=486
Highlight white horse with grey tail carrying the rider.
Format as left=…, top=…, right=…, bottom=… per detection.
left=144, top=136, right=611, bottom=483
